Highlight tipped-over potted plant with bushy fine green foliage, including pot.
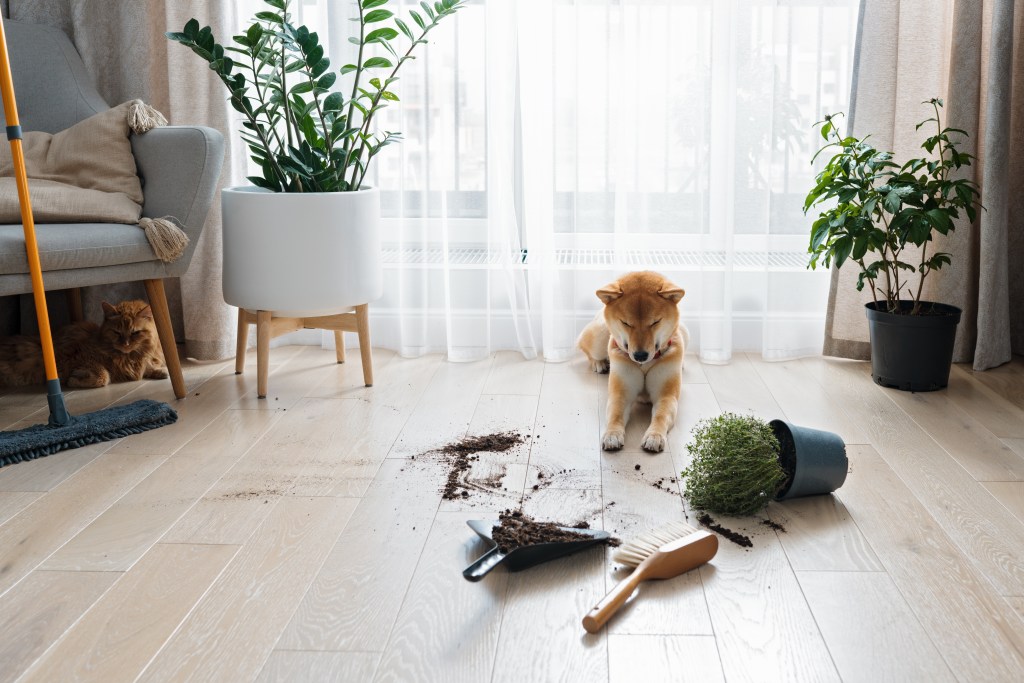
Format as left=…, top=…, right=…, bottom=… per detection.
left=681, top=413, right=849, bottom=516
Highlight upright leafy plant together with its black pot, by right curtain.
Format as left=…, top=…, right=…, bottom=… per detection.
left=804, top=98, right=981, bottom=391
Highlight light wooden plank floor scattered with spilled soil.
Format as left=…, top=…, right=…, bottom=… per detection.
left=0, top=346, right=1024, bottom=683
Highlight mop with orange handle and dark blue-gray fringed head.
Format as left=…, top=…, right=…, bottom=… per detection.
left=0, top=14, right=178, bottom=467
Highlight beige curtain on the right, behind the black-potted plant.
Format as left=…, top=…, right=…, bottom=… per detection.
left=824, top=0, right=1024, bottom=370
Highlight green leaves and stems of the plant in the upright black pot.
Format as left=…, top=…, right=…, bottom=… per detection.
left=804, top=98, right=984, bottom=315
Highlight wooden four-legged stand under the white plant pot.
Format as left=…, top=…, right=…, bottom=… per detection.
left=234, top=304, right=374, bottom=398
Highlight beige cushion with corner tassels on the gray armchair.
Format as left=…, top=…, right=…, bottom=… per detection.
left=0, top=99, right=188, bottom=262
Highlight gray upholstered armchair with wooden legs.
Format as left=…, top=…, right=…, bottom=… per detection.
left=0, top=20, right=224, bottom=398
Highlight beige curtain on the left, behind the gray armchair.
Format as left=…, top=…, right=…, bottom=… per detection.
left=6, top=0, right=245, bottom=360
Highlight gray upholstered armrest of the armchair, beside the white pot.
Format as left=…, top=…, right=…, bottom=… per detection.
left=131, top=126, right=224, bottom=276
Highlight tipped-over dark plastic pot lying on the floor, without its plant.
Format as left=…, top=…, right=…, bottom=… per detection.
left=768, top=420, right=850, bottom=501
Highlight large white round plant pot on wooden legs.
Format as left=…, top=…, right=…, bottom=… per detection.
left=221, top=186, right=384, bottom=317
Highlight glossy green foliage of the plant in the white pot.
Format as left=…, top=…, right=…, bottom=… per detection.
left=166, top=0, right=466, bottom=193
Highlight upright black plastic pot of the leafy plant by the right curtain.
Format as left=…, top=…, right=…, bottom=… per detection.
left=864, top=301, right=961, bottom=391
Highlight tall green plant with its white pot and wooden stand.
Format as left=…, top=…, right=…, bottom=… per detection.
left=167, top=0, right=464, bottom=396
